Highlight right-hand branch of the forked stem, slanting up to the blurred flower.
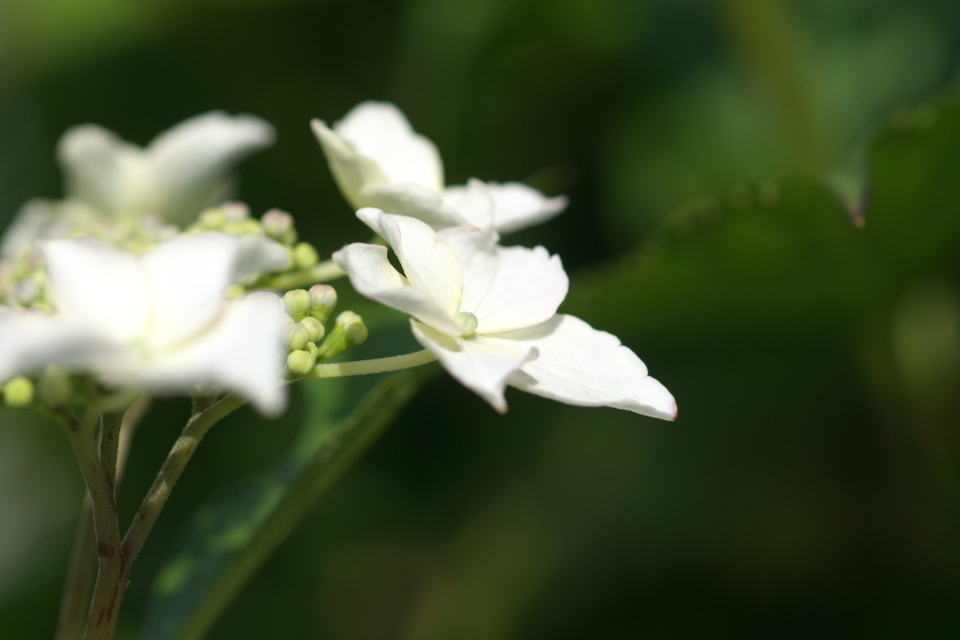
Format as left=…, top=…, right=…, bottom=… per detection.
left=122, top=395, right=247, bottom=571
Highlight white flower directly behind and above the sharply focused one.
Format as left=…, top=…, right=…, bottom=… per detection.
left=311, top=102, right=567, bottom=232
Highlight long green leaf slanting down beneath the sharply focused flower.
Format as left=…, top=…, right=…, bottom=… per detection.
left=142, top=367, right=435, bottom=640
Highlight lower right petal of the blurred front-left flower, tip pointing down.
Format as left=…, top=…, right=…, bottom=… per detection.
left=101, top=292, right=287, bottom=415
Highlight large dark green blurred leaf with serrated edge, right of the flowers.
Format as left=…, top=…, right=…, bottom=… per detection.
left=565, top=93, right=960, bottom=348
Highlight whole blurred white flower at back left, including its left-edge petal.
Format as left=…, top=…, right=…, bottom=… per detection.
left=2, top=111, right=275, bottom=260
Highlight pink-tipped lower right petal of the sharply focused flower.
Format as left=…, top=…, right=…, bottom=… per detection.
left=483, top=315, right=677, bottom=420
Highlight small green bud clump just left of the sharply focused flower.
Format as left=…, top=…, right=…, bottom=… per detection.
left=283, top=284, right=368, bottom=378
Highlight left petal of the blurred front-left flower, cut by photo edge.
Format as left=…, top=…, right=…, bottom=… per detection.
left=0, top=311, right=123, bottom=382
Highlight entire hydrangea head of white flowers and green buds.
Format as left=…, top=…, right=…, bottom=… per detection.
left=0, top=102, right=676, bottom=419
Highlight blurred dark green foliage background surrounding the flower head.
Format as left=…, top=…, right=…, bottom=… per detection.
left=0, top=0, right=960, bottom=640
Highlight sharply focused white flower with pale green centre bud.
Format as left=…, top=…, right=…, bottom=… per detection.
left=333, top=209, right=677, bottom=420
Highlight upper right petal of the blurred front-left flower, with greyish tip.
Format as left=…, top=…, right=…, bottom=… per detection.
left=141, top=233, right=289, bottom=349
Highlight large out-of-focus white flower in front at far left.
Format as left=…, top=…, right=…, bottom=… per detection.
left=0, top=233, right=289, bottom=414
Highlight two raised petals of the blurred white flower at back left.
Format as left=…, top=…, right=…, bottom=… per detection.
left=57, top=112, right=274, bottom=224
